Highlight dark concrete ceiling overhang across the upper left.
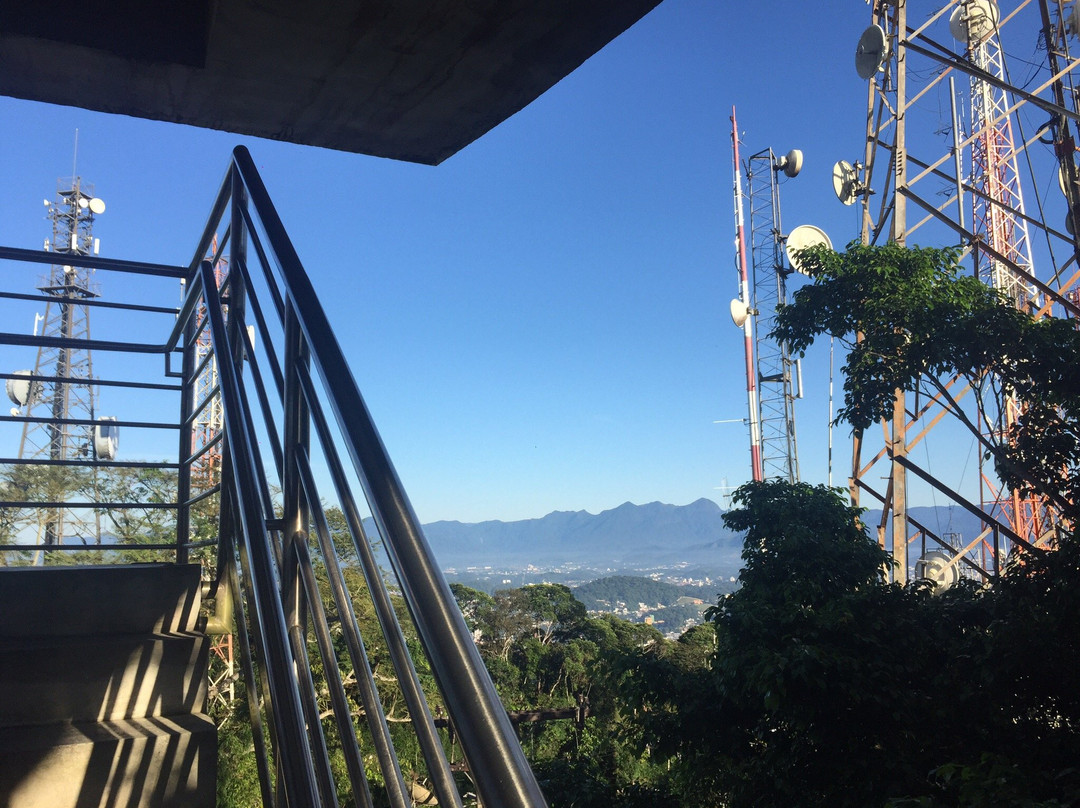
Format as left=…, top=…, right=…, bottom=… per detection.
left=0, top=0, right=660, bottom=164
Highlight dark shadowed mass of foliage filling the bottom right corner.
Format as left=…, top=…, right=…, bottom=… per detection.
left=624, top=481, right=1080, bottom=808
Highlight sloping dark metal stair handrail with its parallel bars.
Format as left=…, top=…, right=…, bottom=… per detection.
left=166, top=148, right=545, bottom=808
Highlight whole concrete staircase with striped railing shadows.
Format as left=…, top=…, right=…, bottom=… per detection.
left=0, top=564, right=217, bottom=808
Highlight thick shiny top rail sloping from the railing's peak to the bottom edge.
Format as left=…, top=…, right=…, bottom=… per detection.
left=233, top=146, right=546, bottom=808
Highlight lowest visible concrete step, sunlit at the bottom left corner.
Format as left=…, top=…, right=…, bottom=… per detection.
left=0, top=714, right=217, bottom=808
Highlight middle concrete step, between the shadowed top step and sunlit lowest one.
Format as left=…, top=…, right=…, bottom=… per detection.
left=0, top=633, right=210, bottom=726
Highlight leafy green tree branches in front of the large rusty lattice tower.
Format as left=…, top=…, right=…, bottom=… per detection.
left=773, top=243, right=1080, bottom=523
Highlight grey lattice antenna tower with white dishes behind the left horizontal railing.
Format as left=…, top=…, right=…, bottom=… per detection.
left=6, top=176, right=117, bottom=546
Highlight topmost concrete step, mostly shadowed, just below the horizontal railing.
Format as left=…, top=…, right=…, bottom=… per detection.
left=0, top=564, right=200, bottom=637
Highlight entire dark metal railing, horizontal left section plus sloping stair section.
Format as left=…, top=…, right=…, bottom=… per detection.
left=0, top=148, right=545, bottom=808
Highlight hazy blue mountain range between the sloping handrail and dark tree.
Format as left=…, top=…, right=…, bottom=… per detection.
left=423, top=499, right=742, bottom=574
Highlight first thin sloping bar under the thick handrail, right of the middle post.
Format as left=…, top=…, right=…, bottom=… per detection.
left=299, top=372, right=461, bottom=808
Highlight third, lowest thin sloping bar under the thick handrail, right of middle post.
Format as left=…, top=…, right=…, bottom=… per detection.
left=293, top=531, right=373, bottom=808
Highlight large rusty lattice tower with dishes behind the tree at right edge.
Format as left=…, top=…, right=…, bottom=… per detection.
left=834, top=0, right=1080, bottom=582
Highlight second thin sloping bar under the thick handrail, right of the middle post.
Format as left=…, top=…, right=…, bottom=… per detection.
left=297, top=453, right=412, bottom=808
